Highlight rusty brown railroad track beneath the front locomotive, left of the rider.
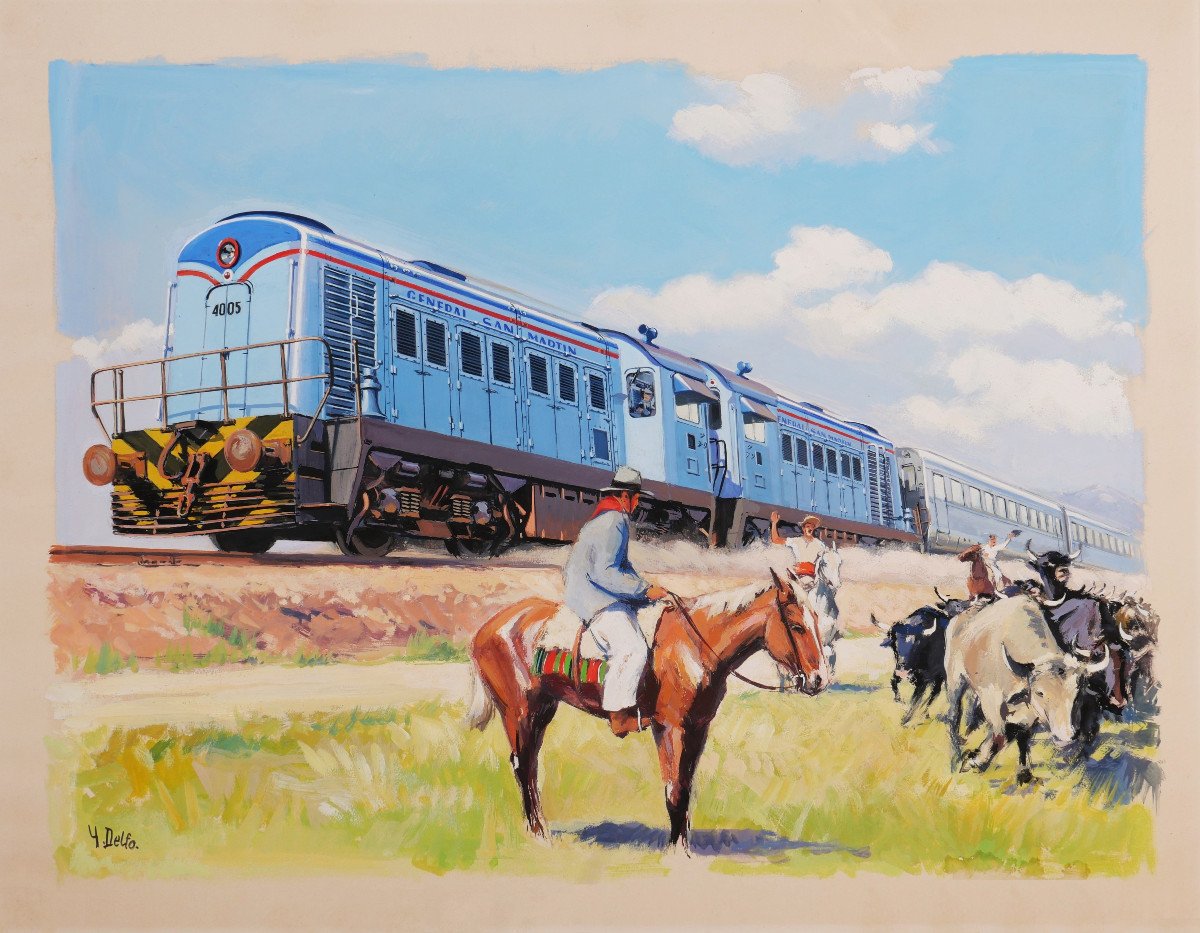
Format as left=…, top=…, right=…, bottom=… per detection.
left=50, top=544, right=556, bottom=570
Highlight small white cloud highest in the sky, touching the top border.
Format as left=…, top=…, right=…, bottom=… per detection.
left=670, top=67, right=942, bottom=167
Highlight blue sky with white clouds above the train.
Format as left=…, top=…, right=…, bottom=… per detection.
left=49, top=55, right=1147, bottom=541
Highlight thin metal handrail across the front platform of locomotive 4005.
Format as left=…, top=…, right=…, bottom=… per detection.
left=91, top=337, right=334, bottom=441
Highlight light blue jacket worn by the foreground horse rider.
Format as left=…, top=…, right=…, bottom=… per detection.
left=563, top=511, right=650, bottom=621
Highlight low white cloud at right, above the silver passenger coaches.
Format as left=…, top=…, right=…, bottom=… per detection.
left=889, top=347, right=1133, bottom=440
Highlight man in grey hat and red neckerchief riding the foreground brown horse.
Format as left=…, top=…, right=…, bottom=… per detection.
left=563, top=467, right=667, bottom=738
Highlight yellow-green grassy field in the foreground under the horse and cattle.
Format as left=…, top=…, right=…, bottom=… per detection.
left=48, top=666, right=1160, bottom=879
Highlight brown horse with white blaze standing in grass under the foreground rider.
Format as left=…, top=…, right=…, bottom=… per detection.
left=470, top=571, right=829, bottom=851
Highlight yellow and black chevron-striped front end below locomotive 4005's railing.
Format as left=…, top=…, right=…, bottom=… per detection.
left=113, top=415, right=295, bottom=535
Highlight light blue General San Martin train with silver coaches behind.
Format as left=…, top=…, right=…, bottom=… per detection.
left=83, top=211, right=1136, bottom=562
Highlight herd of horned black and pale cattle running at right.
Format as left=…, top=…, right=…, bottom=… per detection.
left=871, top=544, right=1159, bottom=783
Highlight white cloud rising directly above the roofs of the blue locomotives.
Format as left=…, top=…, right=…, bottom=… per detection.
left=589, top=227, right=892, bottom=333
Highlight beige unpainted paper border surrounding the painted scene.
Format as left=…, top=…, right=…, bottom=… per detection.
left=0, top=0, right=1200, bottom=929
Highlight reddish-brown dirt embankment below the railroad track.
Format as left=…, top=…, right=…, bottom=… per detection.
left=48, top=534, right=1146, bottom=673
